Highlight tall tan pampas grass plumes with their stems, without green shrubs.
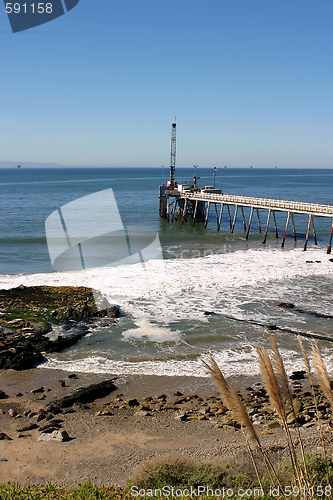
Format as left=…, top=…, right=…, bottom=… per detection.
left=203, top=334, right=333, bottom=498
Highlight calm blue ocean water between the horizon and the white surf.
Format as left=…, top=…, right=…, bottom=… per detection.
left=0, top=168, right=333, bottom=274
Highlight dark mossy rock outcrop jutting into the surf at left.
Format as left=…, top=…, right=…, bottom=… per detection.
left=0, top=285, right=120, bottom=370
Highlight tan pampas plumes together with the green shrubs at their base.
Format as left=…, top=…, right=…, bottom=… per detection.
left=203, top=333, right=333, bottom=498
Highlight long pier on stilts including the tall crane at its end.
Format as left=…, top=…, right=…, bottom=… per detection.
left=159, top=121, right=333, bottom=254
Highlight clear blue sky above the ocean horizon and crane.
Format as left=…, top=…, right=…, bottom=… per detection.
left=0, top=0, right=333, bottom=167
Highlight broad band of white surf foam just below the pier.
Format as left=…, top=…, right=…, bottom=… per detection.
left=0, top=248, right=333, bottom=325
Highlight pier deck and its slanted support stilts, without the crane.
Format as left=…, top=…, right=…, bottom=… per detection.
left=160, top=186, right=333, bottom=254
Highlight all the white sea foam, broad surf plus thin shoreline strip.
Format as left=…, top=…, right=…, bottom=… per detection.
left=0, top=247, right=333, bottom=376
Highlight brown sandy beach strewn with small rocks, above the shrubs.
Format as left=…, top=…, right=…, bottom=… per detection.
left=0, top=368, right=332, bottom=486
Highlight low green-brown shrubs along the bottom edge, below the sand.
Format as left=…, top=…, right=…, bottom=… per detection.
left=0, top=453, right=333, bottom=500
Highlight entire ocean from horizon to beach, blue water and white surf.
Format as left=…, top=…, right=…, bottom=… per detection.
left=0, top=167, right=333, bottom=376
